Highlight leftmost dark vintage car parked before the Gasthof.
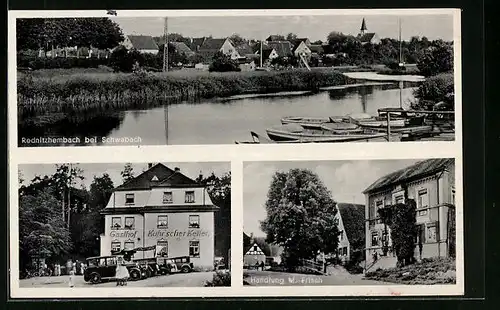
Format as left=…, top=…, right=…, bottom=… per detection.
left=83, top=255, right=146, bottom=284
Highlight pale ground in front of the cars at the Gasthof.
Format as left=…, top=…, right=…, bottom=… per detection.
left=19, top=272, right=214, bottom=288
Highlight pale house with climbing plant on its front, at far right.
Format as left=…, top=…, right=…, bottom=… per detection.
left=363, top=159, right=455, bottom=267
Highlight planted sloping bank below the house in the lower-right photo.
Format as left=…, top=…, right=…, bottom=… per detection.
left=365, top=258, right=456, bottom=285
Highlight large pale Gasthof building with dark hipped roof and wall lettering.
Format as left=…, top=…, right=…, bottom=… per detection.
left=100, top=164, right=218, bottom=269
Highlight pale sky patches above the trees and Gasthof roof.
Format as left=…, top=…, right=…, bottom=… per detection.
left=19, top=162, right=231, bottom=189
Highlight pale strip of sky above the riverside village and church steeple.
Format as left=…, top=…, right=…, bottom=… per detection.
left=111, top=14, right=453, bottom=41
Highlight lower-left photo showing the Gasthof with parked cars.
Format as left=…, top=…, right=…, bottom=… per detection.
left=16, top=162, right=231, bottom=290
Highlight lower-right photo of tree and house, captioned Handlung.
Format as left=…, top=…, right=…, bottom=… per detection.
left=243, top=158, right=463, bottom=293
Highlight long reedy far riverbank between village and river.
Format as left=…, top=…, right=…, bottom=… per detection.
left=17, top=68, right=349, bottom=116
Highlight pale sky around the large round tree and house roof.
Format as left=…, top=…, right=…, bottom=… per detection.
left=243, top=159, right=421, bottom=237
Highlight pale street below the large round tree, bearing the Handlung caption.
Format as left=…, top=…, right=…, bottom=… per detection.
left=244, top=270, right=394, bottom=286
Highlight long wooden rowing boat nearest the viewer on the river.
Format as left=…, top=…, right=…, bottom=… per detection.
left=266, top=124, right=386, bottom=143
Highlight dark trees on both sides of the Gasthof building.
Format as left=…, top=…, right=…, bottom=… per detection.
left=19, top=163, right=231, bottom=271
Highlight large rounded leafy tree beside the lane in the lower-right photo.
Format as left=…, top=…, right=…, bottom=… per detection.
left=261, top=169, right=339, bottom=269
